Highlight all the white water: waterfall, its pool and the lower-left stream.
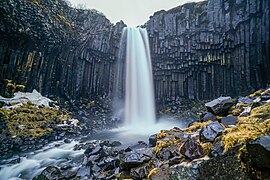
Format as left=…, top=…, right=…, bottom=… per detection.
left=0, top=28, right=181, bottom=180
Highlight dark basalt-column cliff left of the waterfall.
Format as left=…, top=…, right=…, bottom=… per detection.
left=0, top=0, right=125, bottom=98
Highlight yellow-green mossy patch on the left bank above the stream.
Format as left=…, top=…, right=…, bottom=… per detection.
left=0, top=103, right=69, bottom=138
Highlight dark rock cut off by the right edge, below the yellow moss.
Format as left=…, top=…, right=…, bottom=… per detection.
left=247, top=135, right=270, bottom=168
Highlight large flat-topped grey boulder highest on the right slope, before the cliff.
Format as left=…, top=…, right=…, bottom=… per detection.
left=205, top=97, right=233, bottom=115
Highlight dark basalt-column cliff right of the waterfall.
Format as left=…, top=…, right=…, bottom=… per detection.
left=144, top=0, right=270, bottom=101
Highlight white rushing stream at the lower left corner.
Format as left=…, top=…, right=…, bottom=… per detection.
left=0, top=141, right=83, bottom=180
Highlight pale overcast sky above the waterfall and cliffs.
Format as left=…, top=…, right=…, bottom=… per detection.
left=69, top=0, right=200, bottom=27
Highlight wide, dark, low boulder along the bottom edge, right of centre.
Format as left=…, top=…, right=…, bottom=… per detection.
left=171, top=153, right=250, bottom=180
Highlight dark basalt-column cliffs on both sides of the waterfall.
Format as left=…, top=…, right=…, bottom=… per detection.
left=0, top=0, right=270, bottom=102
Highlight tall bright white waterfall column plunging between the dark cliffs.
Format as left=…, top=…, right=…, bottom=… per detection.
left=122, top=28, right=156, bottom=129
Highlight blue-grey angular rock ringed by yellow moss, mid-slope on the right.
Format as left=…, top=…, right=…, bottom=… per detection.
left=200, top=121, right=224, bottom=142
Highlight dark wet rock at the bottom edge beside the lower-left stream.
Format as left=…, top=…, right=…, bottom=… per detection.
left=33, top=166, right=62, bottom=180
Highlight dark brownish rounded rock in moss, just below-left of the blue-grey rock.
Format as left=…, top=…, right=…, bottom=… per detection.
left=180, top=138, right=203, bottom=160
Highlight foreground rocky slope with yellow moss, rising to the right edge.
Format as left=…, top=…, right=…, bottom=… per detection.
left=32, top=88, right=270, bottom=179
